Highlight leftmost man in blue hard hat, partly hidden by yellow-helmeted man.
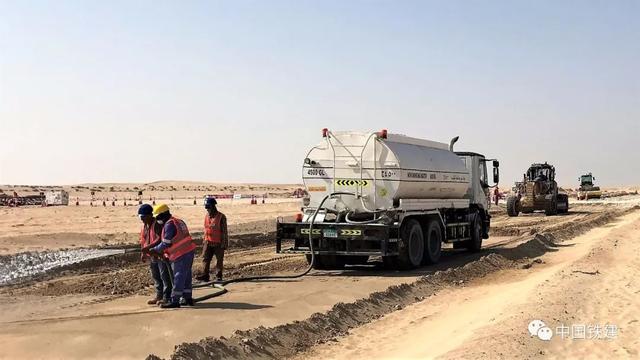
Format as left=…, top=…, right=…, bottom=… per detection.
left=138, top=204, right=172, bottom=305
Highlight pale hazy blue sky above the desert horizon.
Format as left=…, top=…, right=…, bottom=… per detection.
left=0, top=0, right=640, bottom=186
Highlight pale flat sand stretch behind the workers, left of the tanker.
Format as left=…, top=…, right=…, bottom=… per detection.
left=0, top=199, right=301, bottom=255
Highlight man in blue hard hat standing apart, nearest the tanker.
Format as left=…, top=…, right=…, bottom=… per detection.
left=196, top=197, right=229, bottom=281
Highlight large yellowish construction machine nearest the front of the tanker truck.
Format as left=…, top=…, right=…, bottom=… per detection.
left=507, top=162, right=569, bottom=216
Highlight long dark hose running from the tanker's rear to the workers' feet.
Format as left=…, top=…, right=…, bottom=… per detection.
left=193, top=191, right=357, bottom=303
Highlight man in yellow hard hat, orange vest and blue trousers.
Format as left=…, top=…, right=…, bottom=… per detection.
left=144, top=204, right=196, bottom=308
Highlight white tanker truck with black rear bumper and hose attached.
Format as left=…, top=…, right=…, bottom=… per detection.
left=276, top=129, right=499, bottom=269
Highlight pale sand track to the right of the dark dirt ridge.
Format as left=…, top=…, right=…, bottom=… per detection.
left=299, top=212, right=640, bottom=359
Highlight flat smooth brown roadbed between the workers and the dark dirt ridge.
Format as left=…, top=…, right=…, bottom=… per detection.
left=0, top=237, right=512, bottom=359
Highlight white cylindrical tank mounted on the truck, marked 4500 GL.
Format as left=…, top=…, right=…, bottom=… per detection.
left=302, top=131, right=470, bottom=211
